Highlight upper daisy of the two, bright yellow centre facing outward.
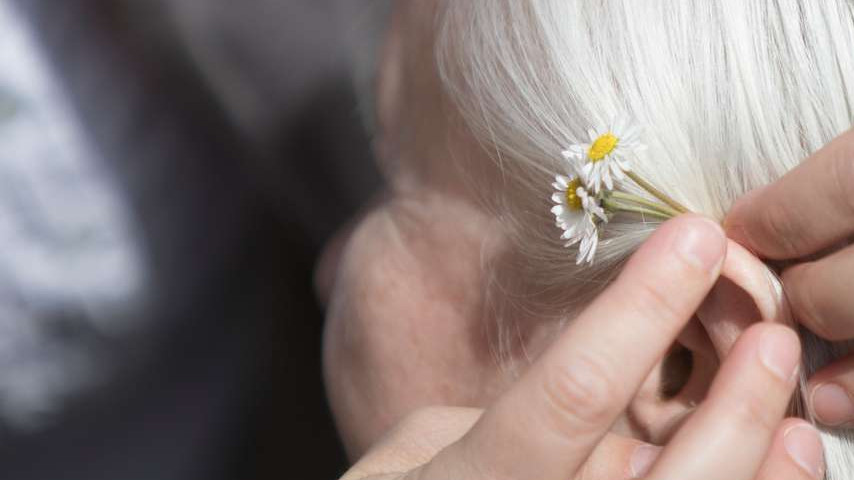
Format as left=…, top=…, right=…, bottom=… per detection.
left=563, top=119, right=646, bottom=193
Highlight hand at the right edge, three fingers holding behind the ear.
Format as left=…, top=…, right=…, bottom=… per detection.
left=725, top=131, right=854, bottom=426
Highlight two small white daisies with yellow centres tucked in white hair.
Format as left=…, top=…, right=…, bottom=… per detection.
left=551, top=122, right=657, bottom=265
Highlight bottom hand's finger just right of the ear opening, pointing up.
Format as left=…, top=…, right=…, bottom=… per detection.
left=648, top=323, right=801, bottom=480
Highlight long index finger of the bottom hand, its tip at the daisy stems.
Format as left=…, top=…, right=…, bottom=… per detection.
left=423, top=215, right=726, bottom=480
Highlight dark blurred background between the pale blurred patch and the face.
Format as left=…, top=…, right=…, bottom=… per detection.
left=0, top=0, right=383, bottom=480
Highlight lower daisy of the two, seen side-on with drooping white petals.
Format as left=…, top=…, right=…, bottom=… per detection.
left=552, top=175, right=608, bottom=264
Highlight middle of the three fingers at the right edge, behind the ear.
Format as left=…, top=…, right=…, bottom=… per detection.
left=783, top=246, right=854, bottom=340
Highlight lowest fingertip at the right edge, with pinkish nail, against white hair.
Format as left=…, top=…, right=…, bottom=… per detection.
left=807, top=356, right=854, bottom=427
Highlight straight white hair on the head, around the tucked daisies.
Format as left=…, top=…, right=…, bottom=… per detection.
left=437, top=0, right=854, bottom=480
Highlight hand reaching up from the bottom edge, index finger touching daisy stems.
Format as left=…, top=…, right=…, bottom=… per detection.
left=344, top=216, right=822, bottom=480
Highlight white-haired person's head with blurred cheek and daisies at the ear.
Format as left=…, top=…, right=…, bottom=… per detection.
left=325, top=0, right=854, bottom=478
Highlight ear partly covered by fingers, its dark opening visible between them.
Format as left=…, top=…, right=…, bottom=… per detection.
left=628, top=241, right=791, bottom=444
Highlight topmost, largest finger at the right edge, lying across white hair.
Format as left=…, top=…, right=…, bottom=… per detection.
left=725, top=127, right=854, bottom=260
